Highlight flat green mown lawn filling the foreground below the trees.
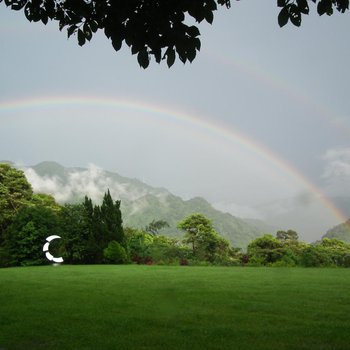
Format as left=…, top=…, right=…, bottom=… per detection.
left=0, top=265, right=350, bottom=350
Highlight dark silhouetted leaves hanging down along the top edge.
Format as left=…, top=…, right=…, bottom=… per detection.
left=0, top=0, right=349, bottom=68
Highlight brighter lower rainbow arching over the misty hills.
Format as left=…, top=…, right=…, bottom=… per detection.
left=0, top=96, right=347, bottom=222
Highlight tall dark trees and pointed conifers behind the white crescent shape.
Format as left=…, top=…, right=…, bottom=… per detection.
left=0, top=164, right=126, bottom=266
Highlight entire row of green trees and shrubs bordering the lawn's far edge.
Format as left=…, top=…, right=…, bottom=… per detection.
left=0, top=164, right=350, bottom=267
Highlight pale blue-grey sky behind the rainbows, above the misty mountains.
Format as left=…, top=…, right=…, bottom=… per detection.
left=0, top=0, right=350, bottom=241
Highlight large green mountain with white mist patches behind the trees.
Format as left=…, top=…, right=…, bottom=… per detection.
left=25, top=162, right=273, bottom=248
